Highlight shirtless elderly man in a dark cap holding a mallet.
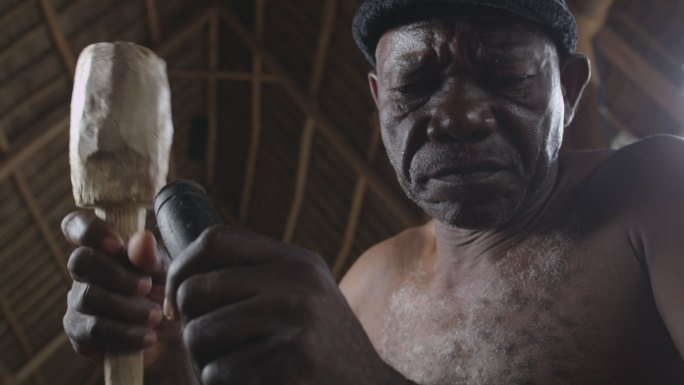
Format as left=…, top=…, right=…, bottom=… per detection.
left=63, top=0, right=684, bottom=385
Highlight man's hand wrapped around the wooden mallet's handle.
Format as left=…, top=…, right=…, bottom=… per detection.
left=62, top=211, right=196, bottom=384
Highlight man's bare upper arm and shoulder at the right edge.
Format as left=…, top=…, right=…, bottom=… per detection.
left=600, top=136, right=684, bottom=357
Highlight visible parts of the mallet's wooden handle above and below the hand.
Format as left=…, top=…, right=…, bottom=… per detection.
left=95, top=205, right=146, bottom=385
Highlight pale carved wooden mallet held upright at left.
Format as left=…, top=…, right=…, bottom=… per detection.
left=69, top=42, right=173, bottom=385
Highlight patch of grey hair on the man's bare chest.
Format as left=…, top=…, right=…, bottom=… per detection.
left=376, top=233, right=596, bottom=385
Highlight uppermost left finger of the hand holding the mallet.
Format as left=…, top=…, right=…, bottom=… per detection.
left=62, top=211, right=125, bottom=256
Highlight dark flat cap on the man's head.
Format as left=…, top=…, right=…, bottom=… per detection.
left=352, top=0, right=577, bottom=67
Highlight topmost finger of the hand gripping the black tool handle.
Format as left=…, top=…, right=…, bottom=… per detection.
left=164, top=226, right=288, bottom=319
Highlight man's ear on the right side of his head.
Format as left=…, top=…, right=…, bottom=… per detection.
left=560, top=54, right=591, bottom=127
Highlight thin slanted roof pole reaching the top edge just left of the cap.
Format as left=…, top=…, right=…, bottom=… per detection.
left=283, top=0, right=338, bottom=242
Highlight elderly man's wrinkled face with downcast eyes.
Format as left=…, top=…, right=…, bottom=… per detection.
left=370, top=12, right=566, bottom=229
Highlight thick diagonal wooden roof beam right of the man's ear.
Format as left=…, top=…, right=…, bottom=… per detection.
left=598, top=27, right=684, bottom=132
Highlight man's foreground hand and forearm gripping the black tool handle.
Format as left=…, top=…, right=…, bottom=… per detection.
left=165, top=227, right=406, bottom=385
